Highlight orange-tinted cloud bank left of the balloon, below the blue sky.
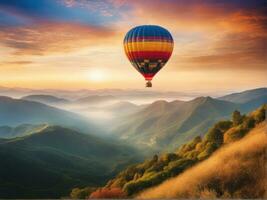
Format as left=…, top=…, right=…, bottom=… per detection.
left=0, top=21, right=115, bottom=55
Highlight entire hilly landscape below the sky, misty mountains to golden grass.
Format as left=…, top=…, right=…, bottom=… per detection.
left=0, top=87, right=267, bottom=199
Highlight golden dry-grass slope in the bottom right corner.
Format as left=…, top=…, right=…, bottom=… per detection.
left=138, top=122, right=267, bottom=199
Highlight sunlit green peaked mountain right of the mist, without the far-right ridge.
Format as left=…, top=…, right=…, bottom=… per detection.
left=113, top=97, right=239, bottom=149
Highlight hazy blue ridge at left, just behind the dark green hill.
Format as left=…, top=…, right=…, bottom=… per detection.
left=0, top=96, right=104, bottom=133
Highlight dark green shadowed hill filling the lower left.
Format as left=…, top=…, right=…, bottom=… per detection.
left=0, top=126, right=140, bottom=198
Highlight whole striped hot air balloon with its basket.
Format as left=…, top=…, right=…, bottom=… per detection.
left=123, top=25, right=173, bottom=87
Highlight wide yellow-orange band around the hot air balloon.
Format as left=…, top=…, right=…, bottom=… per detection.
left=124, top=42, right=173, bottom=51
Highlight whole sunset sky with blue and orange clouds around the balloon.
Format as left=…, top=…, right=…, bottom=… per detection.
left=0, top=0, right=267, bottom=92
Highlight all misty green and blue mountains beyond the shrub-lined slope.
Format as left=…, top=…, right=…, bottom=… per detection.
left=0, top=88, right=267, bottom=198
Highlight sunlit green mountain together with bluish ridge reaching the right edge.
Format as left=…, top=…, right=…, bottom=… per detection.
left=112, top=88, right=267, bottom=151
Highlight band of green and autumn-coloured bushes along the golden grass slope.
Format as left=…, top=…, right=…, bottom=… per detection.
left=85, top=105, right=267, bottom=198
